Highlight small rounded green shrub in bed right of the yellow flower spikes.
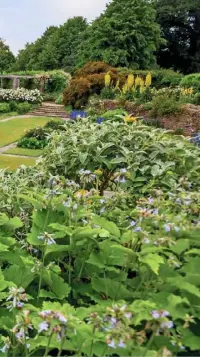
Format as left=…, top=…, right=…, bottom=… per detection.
left=150, top=95, right=181, bottom=118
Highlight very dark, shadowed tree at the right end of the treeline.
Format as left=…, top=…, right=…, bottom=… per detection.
left=155, top=0, right=200, bottom=73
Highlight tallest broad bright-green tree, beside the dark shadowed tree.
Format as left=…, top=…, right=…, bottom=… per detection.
left=78, top=0, right=161, bottom=69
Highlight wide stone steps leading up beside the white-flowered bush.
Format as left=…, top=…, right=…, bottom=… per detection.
left=30, top=102, right=69, bottom=119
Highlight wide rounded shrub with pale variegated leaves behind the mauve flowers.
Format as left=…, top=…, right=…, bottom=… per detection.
left=38, top=119, right=200, bottom=194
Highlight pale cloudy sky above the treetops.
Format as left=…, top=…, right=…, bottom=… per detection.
left=0, top=0, right=109, bottom=54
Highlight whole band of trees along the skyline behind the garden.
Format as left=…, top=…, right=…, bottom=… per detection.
left=0, top=0, right=200, bottom=73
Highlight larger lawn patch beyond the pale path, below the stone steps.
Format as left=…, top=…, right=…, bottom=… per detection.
left=0, top=117, right=51, bottom=147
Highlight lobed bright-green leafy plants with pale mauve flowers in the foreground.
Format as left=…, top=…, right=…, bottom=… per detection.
left=0, top=179, right=200, bottom=357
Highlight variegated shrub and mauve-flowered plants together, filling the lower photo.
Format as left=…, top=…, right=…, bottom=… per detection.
left=0, top=119, right=200, bottom=357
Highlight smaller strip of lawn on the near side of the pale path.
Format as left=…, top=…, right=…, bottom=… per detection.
left=0, top=155, right=35, bottom=170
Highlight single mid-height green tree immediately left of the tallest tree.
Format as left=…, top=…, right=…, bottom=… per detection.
left=38, top=16, right=87, bottom=72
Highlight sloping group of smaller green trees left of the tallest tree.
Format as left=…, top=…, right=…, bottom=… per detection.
left=12, top=17, right=87, bottom=71
